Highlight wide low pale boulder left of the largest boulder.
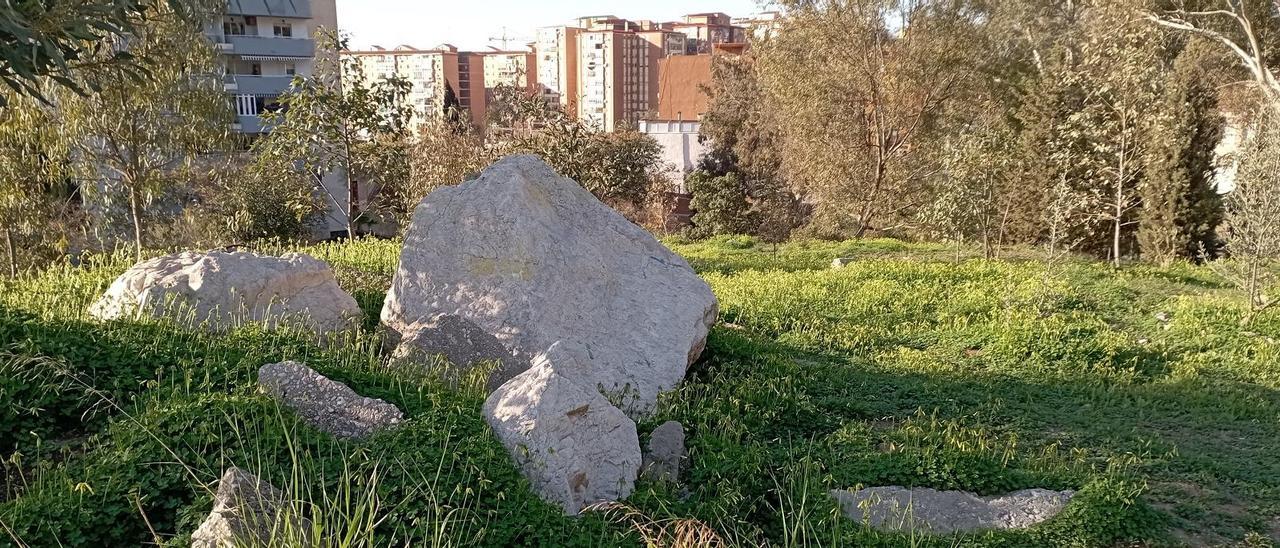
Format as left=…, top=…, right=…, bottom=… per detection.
left=90, top=251, right=361, bottom=334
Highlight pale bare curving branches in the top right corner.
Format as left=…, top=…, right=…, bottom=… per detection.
left=1144, top=0, right=1280, bottom=111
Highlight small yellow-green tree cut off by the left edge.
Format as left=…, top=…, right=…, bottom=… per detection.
left=0, top=93, right=69, bottom=278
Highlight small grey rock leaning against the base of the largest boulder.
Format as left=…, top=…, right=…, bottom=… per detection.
left=392, top=314, right=529, bottom=393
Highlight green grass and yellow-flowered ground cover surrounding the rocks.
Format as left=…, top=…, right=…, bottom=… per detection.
left=0, top=238, right=1280, bottom=547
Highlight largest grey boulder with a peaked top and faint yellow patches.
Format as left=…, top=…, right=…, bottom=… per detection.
left=381, top=156, right=717, bottom=414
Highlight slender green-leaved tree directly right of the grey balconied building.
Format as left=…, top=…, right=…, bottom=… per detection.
left=252, top=31, right=412, bottom=237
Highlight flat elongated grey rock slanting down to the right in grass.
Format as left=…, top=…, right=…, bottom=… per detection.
left=257, top=361, right=404, bottom=439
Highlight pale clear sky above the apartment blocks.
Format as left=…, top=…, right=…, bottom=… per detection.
left=337, top=0, right=760, bottom=50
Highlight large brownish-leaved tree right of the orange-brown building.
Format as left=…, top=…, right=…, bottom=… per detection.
left=758, top=0, right=978, bottom=237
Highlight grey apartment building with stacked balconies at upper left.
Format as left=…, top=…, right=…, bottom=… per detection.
left=215, top=0, right=338, bottom=134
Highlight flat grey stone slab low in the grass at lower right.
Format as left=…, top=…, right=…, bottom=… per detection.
left=831, top=487, right=1075, bottom=534
